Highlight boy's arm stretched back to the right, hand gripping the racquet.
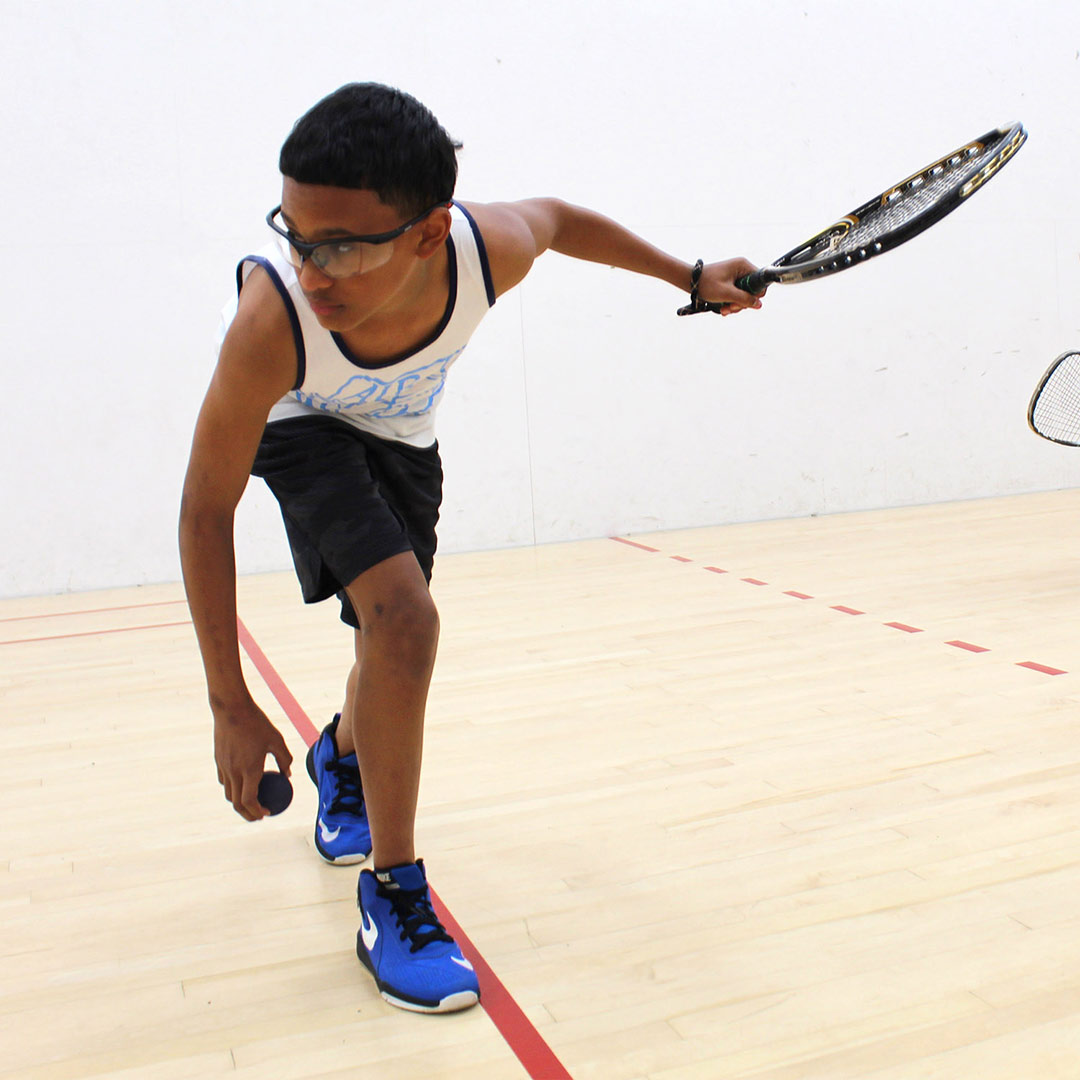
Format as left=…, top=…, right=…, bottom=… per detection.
left=468, top=199, right=761, bottom=312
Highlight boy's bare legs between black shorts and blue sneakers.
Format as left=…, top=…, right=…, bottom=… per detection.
left=338, top=552, right=438, bottom=867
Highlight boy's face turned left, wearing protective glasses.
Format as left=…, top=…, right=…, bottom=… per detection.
left=280, top=177, right=449, bottom=334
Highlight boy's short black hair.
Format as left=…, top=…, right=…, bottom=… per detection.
left=279, top=82, right=459, bottom=216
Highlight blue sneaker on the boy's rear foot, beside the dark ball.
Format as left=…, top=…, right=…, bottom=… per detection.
left=308, top=713, right=372, bottom=866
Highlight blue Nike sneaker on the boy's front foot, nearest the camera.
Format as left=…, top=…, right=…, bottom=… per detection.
left=356, top=860, right=480, bottom=1012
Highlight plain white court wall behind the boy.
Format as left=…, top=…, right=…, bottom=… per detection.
left=0, top=0, right=1080, bottom=595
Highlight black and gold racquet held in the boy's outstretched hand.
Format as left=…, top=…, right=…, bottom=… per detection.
left=678, top=123, right=1027, bottom=315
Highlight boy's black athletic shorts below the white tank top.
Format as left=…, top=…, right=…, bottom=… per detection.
left=252, top=416, right=443, bottom=627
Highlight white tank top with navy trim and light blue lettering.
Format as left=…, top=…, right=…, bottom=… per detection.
left=230, top=203, right=495, bottom=447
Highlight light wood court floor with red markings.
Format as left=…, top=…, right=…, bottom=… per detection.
left=0, top=491, right=1080, bottom=1080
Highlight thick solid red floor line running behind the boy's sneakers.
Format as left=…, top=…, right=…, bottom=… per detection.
left=237, top=617, right=574, bottom=1080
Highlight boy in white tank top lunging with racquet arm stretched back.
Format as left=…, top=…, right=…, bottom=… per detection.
left=180, top=84, right=760, bottom=1012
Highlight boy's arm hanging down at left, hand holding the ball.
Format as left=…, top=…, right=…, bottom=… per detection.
left=179, top=271, right=296, bottom=820
